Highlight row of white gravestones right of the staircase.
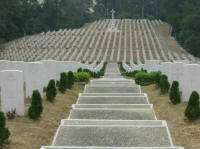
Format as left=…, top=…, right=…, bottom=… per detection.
left=126, top=60, right=200, bottom=102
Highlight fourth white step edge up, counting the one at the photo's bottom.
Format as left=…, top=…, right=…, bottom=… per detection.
left=79, top=93, right=147, bottom=97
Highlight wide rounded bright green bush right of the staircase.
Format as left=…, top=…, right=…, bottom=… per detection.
left=135, top=72, right=154, bottom=86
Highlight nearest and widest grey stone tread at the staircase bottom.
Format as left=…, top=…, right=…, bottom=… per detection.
left=53, top=125, right=172, bottom=147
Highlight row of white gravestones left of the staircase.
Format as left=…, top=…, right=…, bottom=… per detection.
left=0, top=60, right=103, bottom=115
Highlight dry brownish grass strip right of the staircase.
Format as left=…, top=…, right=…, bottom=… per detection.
left=142, top=85, right=200, bottom=149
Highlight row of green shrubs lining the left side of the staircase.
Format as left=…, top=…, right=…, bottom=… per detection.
left=0, top=63, right=106, bottom=148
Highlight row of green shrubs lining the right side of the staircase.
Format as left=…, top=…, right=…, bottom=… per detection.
left=119, top=66, right=200, bottom=120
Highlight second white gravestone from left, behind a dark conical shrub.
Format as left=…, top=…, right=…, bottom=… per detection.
left=24, top=62, right=44, bottom=97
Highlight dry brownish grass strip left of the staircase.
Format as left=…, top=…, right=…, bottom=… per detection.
left=0, top=85, right=84, bottom=149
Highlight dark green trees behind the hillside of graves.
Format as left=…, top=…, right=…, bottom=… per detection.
left=0, top=0, right=200, bottom=57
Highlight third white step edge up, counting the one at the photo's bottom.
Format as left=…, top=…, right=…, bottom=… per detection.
left=72, top=104, right=153, bottom=109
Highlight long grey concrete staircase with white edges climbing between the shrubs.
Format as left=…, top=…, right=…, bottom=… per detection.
left=41, top=64, right=183, bottom=149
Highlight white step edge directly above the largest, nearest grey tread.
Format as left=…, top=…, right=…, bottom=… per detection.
left=61, top=119, right=166, bottom=126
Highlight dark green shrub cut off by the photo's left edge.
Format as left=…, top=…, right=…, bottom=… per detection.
left=0, top=112, right=10, bottom=148
